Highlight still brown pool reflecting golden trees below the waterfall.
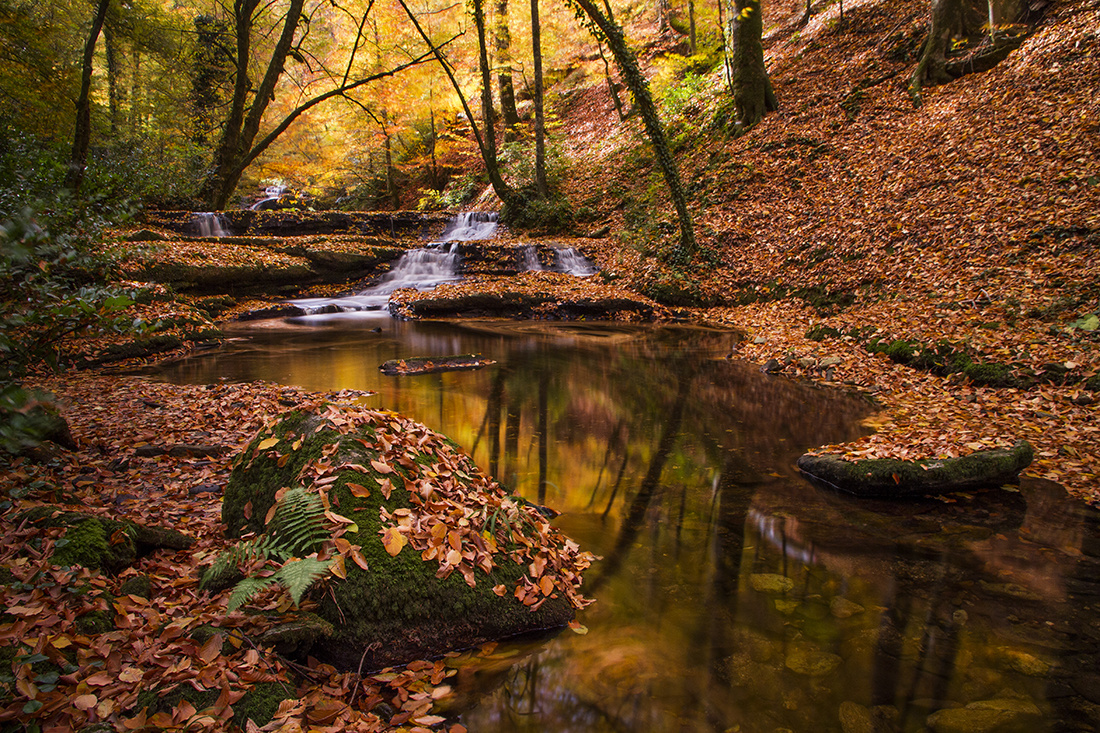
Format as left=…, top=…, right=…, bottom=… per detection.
left=152, top=313, right=1100, bottom=733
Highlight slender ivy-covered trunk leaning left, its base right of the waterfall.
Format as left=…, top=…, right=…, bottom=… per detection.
left=573, top=0, right=695, bottom=259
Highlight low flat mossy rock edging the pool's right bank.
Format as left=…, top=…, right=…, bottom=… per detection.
left=798, top=440, right=1034, bottom=499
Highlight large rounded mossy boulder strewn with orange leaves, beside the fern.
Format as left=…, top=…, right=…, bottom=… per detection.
left=222, top=402, right=591, bottom=669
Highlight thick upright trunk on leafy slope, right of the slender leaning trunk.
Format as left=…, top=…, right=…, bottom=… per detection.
left=729, top=0, right=779, bottom=132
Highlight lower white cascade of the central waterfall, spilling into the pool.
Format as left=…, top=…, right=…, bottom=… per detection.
left=290, top=243, right=460, bottom=315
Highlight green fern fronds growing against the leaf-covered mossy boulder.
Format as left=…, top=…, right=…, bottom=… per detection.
left=200, top=488, right=331, bottom=612
